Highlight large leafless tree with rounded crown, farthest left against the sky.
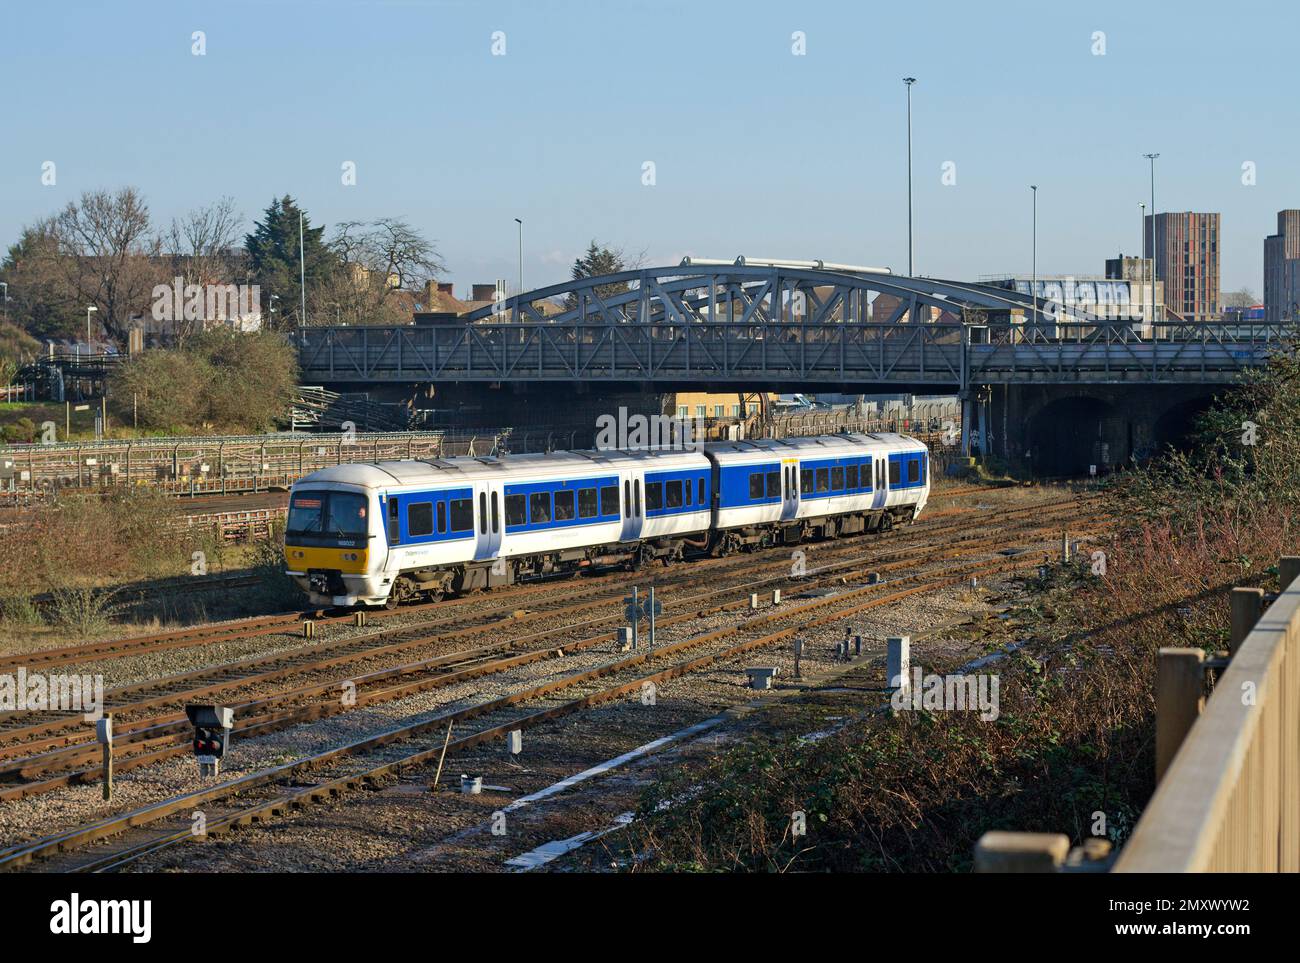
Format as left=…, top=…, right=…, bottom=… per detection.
left=53, top=187, right=163, bottom=344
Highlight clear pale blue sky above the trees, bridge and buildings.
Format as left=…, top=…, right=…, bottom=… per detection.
left=0, top=0, right=1300, bottom=294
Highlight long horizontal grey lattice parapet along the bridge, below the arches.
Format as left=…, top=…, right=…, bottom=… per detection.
left=299, top=321, right=1300, bottom=390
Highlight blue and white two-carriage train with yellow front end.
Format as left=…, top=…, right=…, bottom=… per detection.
left=285, top=434, right=930, bottom=607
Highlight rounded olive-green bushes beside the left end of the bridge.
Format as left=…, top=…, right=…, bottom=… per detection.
left=109, top=329, right=298, bottom=433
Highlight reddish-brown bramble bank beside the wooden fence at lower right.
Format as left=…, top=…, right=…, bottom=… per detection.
left=623, top=355, right=1300, bottom=872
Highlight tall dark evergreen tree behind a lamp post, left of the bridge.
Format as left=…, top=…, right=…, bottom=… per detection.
left=244, top=194, right=338, bottom=329
